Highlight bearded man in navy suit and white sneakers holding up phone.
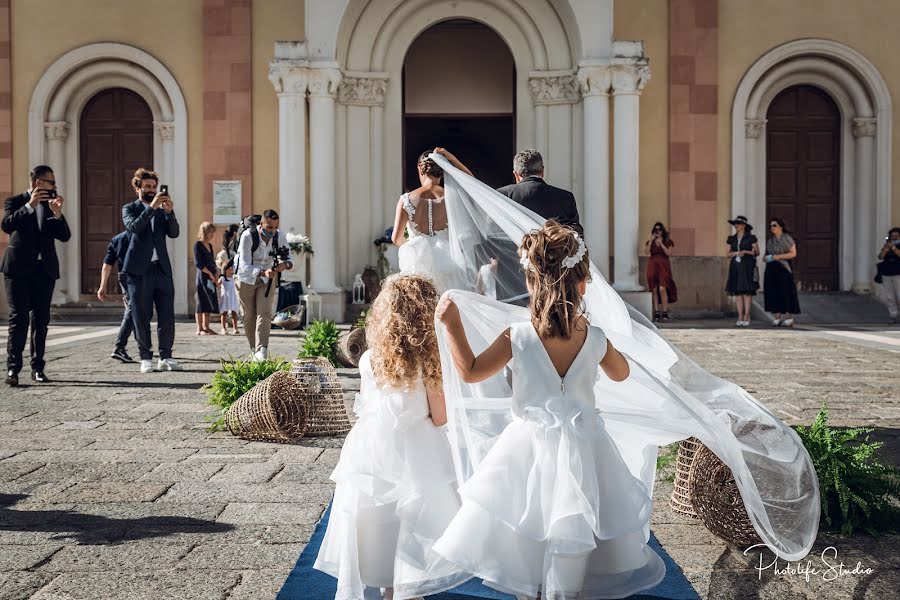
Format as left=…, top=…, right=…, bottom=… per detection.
left=122, top=167, right=181, bottom=373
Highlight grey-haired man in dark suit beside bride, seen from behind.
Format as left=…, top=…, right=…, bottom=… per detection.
left=497, top=150, right=583, bottom=234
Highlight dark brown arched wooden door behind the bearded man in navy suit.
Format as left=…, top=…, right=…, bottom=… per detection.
left=79, top=88, right=153, bottom=295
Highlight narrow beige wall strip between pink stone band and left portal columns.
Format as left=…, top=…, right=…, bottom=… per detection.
left=252, top=0, right=305, bottom=213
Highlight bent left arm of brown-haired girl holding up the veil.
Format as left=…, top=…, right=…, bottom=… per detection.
left=435, top=298, right=512, bottom=383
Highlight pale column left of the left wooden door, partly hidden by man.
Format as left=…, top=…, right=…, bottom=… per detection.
left=44, top=121, right=69, bottom=304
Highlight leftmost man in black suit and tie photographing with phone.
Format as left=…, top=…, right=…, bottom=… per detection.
left=0, top=165, right=72, bottom=386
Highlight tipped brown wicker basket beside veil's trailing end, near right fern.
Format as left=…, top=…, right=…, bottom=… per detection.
left=688, top=444, right=762, bottom=548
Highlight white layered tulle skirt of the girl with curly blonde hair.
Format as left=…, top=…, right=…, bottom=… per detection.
left=315, top=416, right=470, bottom=600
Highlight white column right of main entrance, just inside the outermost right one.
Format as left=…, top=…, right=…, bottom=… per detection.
left=578, top=66, right=612, bottom=279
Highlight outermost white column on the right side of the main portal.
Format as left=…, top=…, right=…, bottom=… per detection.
left=612, top=61, right=650, bottom=292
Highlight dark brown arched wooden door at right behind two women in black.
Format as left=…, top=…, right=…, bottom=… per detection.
left=761, top=85, right=841, bottom=291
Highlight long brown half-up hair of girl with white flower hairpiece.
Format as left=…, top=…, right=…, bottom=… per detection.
left=519, top=219, right=591, bottom=339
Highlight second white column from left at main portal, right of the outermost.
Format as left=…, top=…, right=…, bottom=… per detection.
left=309, top=68, right=343, bottom=296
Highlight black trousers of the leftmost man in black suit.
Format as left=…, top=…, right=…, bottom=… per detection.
left=5, top=266, right=56, bottom=373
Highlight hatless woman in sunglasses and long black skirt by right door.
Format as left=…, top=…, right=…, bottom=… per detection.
left=763, top=218, right=800, bottom=327
